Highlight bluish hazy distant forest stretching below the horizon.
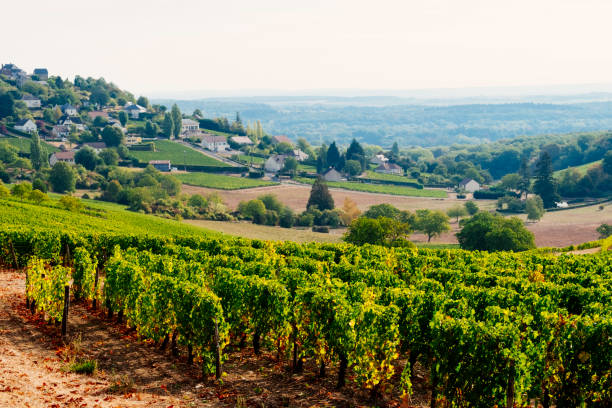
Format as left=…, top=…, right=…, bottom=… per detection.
left=155, top=97, right=612, bottom=147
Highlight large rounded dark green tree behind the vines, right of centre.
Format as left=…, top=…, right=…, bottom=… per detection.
left=457, top=212, right=535, bottom=251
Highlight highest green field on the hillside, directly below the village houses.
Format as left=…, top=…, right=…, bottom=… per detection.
left=130, top=140, right=229, bottom=167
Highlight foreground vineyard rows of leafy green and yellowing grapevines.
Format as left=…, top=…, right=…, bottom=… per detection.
left=0, top=227, right=612, bottom=407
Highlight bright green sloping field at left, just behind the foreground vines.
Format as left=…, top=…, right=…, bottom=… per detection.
left=0, top=195, right=219, bottom=236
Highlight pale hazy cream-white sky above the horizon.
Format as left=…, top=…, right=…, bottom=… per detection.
left=0, top=0, right=612, bottom=95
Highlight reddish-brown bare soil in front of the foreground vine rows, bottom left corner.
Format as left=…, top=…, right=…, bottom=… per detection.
left=0, top=270, right=429, bottom=407
